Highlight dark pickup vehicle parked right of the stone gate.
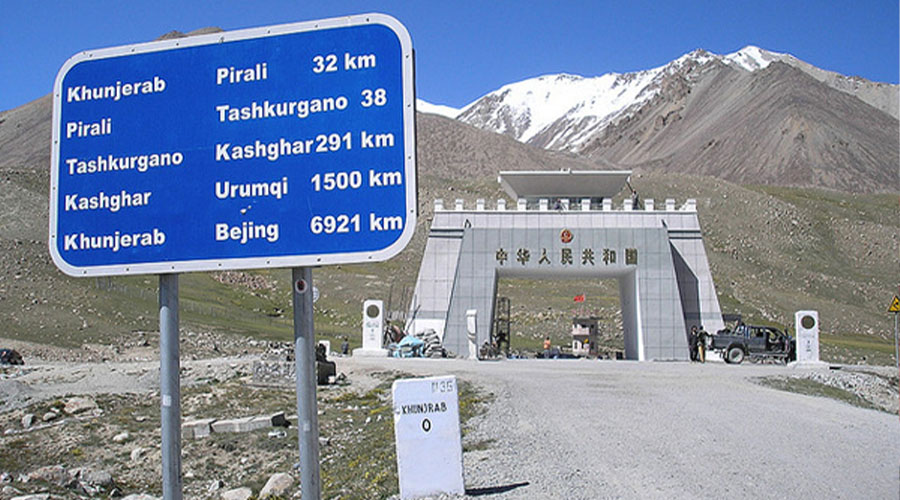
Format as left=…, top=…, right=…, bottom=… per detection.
left=709, top=315, right=797, bottom=364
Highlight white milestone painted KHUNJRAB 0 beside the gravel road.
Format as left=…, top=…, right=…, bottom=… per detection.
left=392, top=376, right=465, bottom=500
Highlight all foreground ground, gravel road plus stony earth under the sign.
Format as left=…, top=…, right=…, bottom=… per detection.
left=0, top=339, right=900, bottom=499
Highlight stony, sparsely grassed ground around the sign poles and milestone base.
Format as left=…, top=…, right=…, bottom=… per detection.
left=0, top=369, right=491, bottom=499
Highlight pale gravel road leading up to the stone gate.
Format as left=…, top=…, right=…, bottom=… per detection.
left=348, top=358, right=900, bottom=499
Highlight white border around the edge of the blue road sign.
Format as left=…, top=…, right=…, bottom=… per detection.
left=47, top=13, right=418, bottom=277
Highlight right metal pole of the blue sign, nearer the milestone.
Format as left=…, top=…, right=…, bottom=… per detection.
left=291, top=267, right=321, bottom=500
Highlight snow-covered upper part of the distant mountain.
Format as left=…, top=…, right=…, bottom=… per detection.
left=458, top=46, right=897, bottom=152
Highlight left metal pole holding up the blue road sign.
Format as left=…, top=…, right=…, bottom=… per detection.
left=159, top=274, right=181, bottom=500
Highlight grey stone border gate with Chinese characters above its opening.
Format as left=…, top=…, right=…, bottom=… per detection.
left=406, top=170, right=723, bottom=361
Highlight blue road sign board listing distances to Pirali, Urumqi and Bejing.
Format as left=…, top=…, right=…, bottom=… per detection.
left=50, top=14, right=416, bottom=276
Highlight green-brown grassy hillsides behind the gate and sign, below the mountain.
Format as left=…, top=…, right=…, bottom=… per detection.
left=0, top=82, right=900, bottom=362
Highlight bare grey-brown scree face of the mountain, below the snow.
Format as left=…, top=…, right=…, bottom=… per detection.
left=582, top=62, right=900, bottom=192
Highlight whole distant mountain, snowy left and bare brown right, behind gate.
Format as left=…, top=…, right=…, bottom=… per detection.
left=457, top=47, right=900, bottom=192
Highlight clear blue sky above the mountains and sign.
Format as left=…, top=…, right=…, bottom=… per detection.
left=0, top=0, right=900, bottom=110
